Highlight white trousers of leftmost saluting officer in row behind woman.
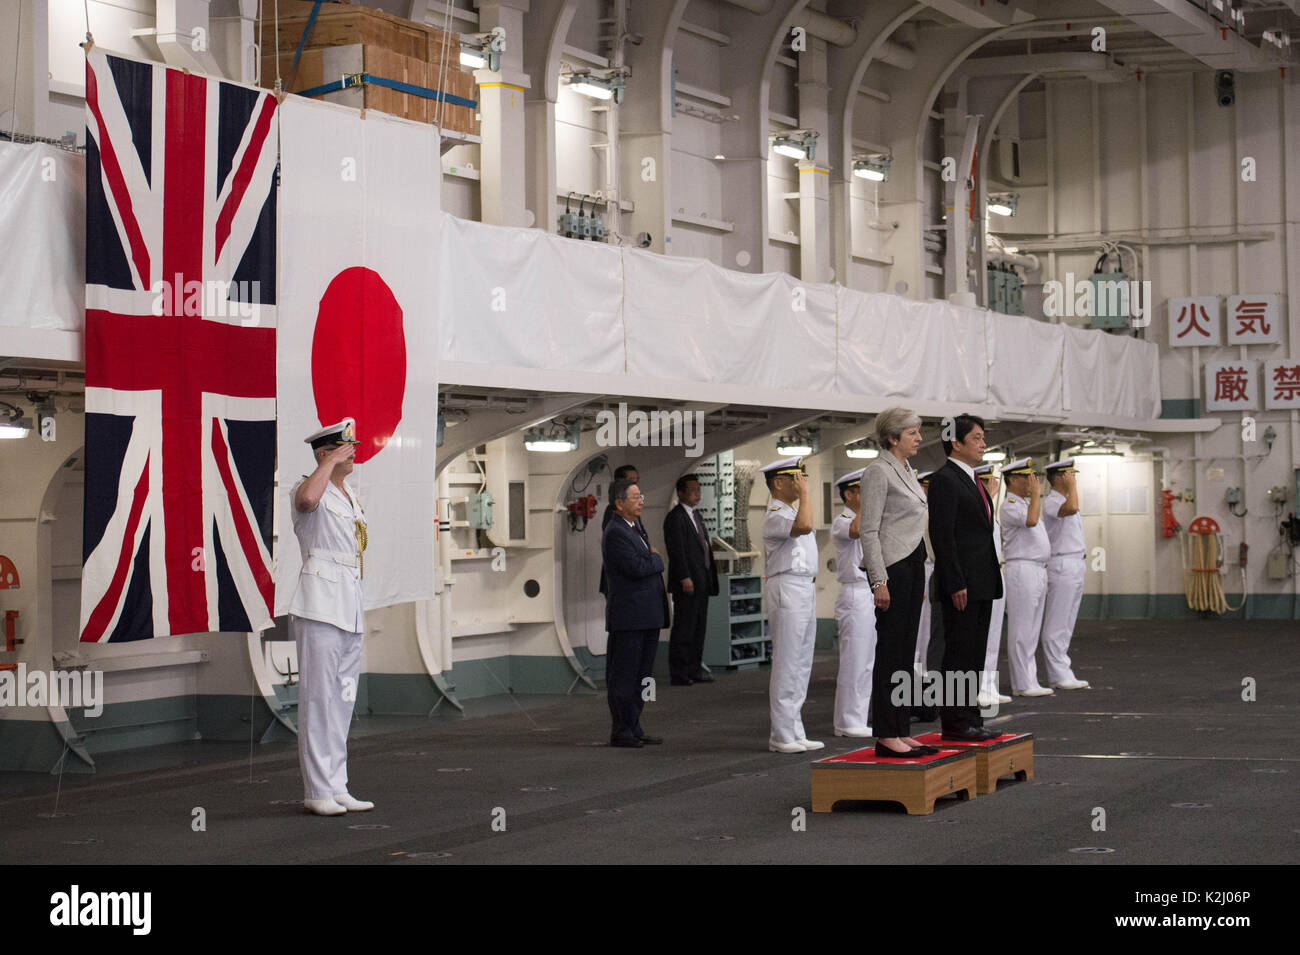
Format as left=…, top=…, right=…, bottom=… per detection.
left=763, top=573, right=816, bottom=743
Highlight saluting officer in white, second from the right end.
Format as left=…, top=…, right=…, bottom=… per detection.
left=1000, top=457, right=1052, bottom=696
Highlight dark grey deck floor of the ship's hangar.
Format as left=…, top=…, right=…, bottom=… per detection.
left=0, top=621, right=1300, bottom=865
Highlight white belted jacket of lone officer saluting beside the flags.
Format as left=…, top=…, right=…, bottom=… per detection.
left=289, top=478, right=365, bottom=633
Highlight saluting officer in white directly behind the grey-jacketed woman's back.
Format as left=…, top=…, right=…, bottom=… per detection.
left=831, top=468, right=876, bottom=737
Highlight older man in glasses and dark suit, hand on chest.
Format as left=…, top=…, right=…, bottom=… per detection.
left=601, top=481, right=668, bottom=748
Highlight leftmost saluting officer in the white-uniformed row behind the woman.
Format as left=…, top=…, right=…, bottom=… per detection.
left=763, top=457, right=826, bottom=752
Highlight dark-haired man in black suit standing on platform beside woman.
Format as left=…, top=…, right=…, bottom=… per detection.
left=930, top=414, right=1002, bottom=742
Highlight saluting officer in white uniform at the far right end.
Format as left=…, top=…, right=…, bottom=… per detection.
left=1043, top=457, right=1088, bottom=690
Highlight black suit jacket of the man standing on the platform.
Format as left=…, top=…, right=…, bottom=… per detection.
left=930, top=460, right=1002, bottom=600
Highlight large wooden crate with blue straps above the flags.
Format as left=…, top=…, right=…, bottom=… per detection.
left=260, top=0, right=478, bottom=134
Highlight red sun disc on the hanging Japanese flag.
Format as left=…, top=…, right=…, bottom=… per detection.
left=312, top=266, right=406, bottom=464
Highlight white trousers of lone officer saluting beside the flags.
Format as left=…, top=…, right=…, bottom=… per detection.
left=289, top=616, right=361, bottom=799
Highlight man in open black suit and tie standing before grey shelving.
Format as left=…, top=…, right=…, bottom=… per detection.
left=663, top=474, right=718, bottom=686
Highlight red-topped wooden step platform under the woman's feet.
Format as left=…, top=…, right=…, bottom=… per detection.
left=813, top=746, right=976, bottom=816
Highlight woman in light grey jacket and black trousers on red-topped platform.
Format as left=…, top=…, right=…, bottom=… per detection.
left=859, top=408, right=939, bottom=759
